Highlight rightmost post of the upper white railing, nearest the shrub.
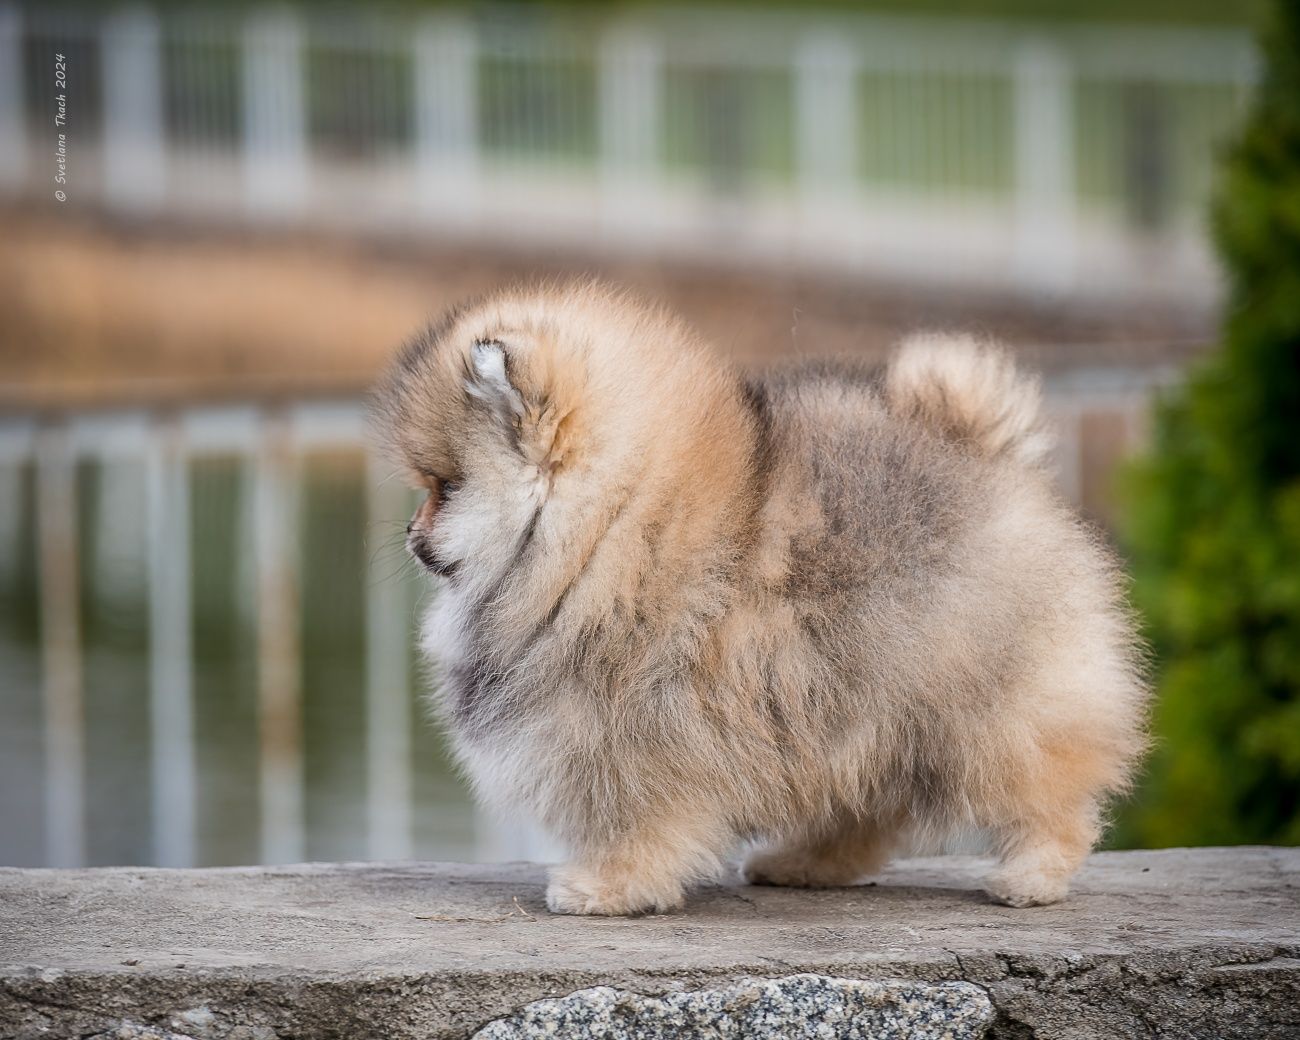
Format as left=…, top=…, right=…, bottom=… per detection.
left=1014, top=39, right=1076, bottom=293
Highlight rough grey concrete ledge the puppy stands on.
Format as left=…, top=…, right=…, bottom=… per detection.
left=0, top=848, right=1300, bottom=1040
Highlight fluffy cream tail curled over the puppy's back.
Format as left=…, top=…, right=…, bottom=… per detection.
left=885, top=334, right=1052, bottom=465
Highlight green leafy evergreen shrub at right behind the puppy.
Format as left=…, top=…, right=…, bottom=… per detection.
left=1117, top=0, right=1300, bottom=845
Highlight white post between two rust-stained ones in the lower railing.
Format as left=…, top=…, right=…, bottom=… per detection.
left=146, top=423, right=198, bottom=867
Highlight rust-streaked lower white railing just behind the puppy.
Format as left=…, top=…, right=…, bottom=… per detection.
left=0, top=371, right=1174, bottom=866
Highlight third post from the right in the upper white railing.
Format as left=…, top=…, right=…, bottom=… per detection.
left=598, top=26, right=663, bottom=239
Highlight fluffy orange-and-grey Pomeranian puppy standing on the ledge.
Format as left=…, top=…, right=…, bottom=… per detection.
left=376, top=285, right=1145, bottom=914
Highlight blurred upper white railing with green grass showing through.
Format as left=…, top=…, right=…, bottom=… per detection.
left=0, top=3, right=1255, bottom=299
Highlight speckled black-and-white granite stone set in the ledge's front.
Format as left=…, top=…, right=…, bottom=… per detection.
left=475, top=975, right=993, bottom=1040
